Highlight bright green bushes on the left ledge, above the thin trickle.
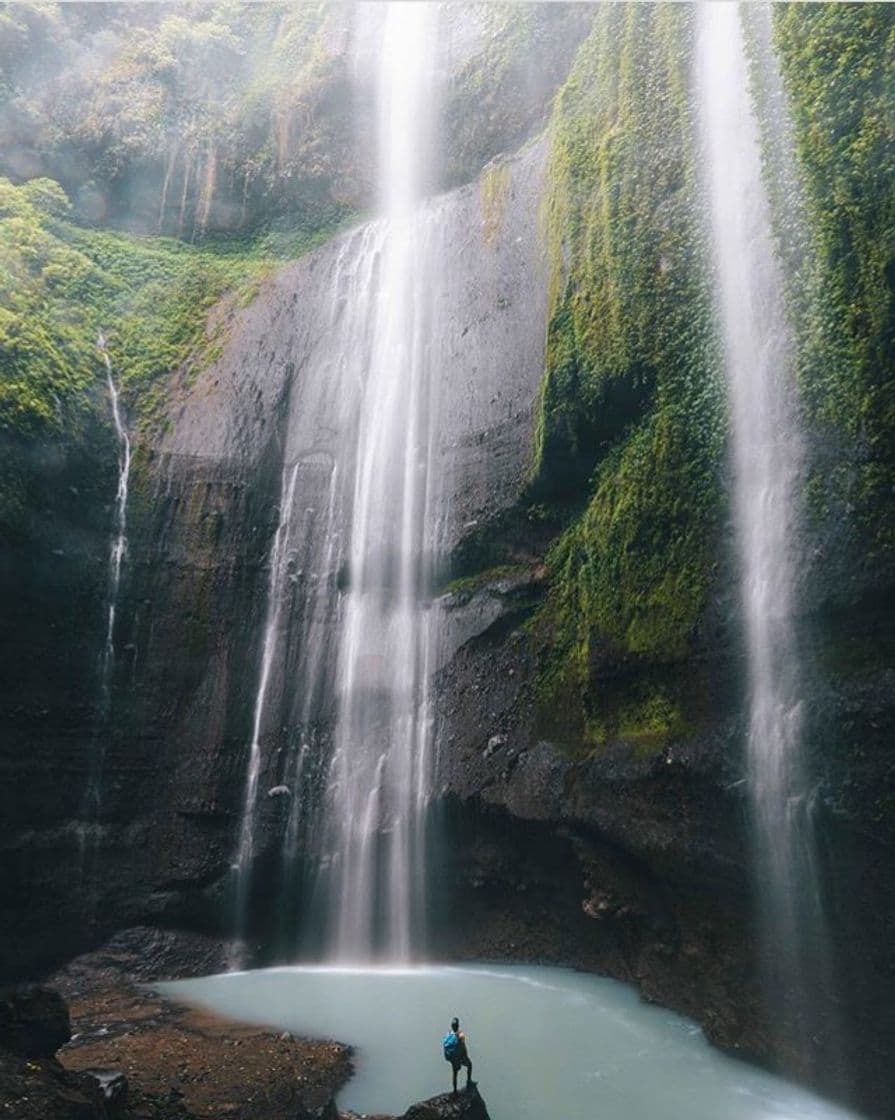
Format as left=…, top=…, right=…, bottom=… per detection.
left=0, top=179, right=270, bottom=436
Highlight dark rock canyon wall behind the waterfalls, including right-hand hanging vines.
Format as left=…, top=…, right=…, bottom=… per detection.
left=0, top=4, right=895, bottom=1114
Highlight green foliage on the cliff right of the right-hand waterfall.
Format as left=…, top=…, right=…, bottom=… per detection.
left=774, top=3, right=895, bottom=561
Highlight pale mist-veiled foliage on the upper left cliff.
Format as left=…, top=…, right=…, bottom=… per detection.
left=0, top=0, right=353, bottom=237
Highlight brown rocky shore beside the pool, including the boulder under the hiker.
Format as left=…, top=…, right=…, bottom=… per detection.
left=0, top=940, right=488, bottom=1120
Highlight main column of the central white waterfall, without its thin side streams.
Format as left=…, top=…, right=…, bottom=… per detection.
left=326, top=2, right=438, bottom=959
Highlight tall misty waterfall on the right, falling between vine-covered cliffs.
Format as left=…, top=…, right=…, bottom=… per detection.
left=697, top=2, right=842, bottom=1075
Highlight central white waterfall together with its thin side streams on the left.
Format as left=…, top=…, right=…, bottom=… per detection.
left=234, top=3, right=440, bottom=960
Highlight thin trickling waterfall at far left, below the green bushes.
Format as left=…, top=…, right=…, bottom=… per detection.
left=84, top=333, right=131, bottom=819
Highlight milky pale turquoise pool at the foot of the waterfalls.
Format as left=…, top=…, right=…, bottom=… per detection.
left=158, top=965, right=854, bottom=1120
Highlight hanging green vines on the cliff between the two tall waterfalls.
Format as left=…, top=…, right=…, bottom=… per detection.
left=532, top=4, right=725, bottom=740
